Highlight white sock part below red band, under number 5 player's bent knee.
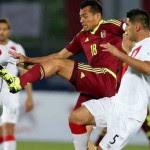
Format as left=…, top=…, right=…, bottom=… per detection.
left=72, top=133, right=89, bottom=150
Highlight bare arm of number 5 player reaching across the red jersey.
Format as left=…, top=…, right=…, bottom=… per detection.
left=101, top=43, right=150, bottom=75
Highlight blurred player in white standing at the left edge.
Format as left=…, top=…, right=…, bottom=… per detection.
left=0, top=19, right=33, bottom=150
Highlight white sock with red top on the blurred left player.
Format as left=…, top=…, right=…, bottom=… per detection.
left=3, top=135, right=16, bottom=150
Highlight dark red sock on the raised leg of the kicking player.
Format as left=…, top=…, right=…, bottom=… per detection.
left=19, top=64, right=43, bottom=88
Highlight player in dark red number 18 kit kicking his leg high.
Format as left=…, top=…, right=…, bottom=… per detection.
left=6, top=0, right=124, bottom=149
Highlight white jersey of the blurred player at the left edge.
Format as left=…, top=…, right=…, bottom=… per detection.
left=0, top=40, right=25, bottom=90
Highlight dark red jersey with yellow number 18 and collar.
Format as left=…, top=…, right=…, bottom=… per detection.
left=66, top=20, right=124, bottom=73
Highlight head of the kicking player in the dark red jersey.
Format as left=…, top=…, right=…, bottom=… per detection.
left=80, top=0, right=102, bottom=31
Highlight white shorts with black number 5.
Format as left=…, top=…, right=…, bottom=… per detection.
left=83, top=97, right=143, bottom=150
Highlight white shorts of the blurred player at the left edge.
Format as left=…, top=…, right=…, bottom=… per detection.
left=0, top=91, right=20, bottom=124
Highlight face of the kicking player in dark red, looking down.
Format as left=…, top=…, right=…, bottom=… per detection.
left=80, top=6, right=101, bottom=31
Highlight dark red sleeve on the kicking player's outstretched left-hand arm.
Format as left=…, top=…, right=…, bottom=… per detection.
left=65, top=33, right=82, bottom=54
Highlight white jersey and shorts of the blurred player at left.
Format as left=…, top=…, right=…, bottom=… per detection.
left=0, top=40, right=25, bottom=124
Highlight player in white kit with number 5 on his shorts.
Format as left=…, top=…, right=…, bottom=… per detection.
left=70, top=9, right=150, bottom=150
